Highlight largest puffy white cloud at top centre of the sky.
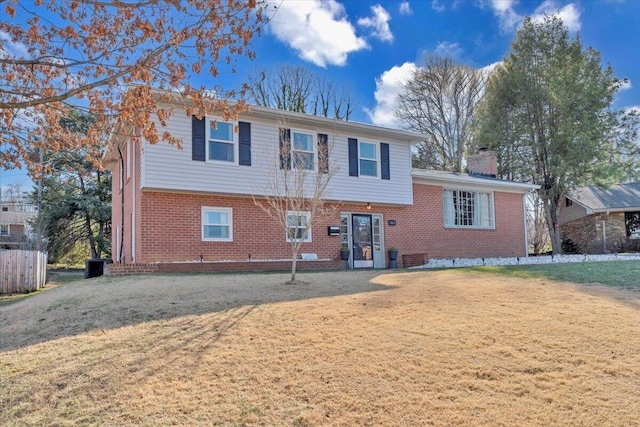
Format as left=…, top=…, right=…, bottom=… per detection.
left=269, top=0, right=369, bottom=67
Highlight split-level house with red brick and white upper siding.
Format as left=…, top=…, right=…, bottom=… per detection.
left=106, top=97, right=537, bottom=274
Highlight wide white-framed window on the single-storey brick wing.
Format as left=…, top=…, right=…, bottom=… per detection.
left=444, top=190, right=494, bottom=228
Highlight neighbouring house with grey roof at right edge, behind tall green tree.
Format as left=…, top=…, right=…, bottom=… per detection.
left=558, top=183, right=640, bottom=253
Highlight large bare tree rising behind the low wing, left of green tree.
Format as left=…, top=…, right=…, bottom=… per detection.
left=394, top=55, right=487, bottom=172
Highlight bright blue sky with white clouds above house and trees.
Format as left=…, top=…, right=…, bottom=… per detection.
left=0, top=0, right=640, bottom=189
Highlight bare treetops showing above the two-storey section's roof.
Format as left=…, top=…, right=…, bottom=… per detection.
left=248, top=64, right=354, bottom=121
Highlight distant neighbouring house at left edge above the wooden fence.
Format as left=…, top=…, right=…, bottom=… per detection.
left=0, top=202, right=36, bottom=249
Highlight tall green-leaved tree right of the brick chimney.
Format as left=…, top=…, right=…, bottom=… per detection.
left=476, top=16, right=638, bottom=253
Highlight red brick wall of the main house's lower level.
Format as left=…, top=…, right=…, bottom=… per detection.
left=114, top=184, right=525, bottom=270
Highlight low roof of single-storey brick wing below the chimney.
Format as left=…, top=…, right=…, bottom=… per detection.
left=411, top=169, right=540, bottom=194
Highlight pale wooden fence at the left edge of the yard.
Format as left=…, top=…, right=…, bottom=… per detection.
left=0, top=250, right=47, bottom=294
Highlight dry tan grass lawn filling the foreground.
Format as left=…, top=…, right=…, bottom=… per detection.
left=0, top=270, right=640, bottom=426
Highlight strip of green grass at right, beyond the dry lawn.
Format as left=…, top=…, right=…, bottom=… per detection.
left=471, top=261, right=640, bottom=289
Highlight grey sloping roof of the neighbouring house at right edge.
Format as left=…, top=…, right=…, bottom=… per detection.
left=567, top=183, right=640, bottom=212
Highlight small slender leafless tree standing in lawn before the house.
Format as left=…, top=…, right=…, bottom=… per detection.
left=253, top=127, right=337, bottom=284
